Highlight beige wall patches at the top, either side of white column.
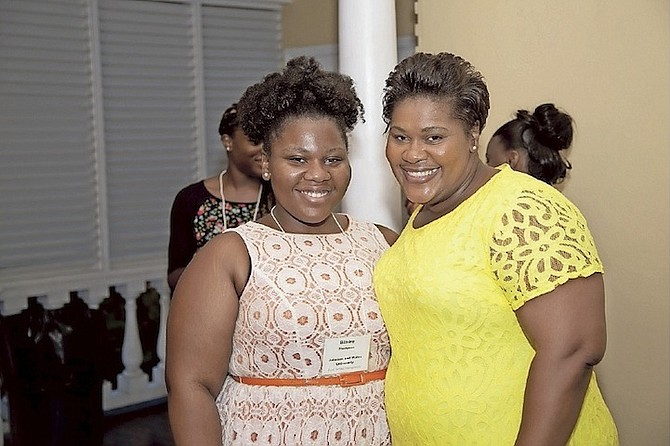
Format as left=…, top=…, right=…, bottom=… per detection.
left=282, top=0, right=415, bottom=48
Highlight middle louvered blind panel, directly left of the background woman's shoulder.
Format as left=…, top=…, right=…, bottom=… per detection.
left=99, top=0, right=197, bottom=265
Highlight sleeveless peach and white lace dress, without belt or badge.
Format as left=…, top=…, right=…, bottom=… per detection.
left=216, top=218, right=390, bottom=446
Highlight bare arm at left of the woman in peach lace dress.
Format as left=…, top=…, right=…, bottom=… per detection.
left=166, top=233, right=249, bottom=446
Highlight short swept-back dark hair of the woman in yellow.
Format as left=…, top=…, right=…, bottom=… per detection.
left=382, top=53, right=490, bottom=131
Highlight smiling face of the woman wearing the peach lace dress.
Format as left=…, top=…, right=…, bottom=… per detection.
left=263, top=117, right=351, bottom=233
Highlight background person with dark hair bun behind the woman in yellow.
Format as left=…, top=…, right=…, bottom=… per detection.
left=486, top=104, right=573, bottom=185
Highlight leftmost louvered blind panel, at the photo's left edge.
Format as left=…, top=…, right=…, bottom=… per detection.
left=0, top=0, right=99, bottom=274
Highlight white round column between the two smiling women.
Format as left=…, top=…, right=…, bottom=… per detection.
left=338, top=0, right=402, bottom=231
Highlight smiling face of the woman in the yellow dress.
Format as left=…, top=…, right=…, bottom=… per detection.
left=386, top=97, right=480, bottom=211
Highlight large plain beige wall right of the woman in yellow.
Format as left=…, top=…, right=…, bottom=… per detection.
left=416, top=0, right=670, bottom=446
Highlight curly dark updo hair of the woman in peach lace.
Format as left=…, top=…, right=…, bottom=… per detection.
left=238, top=56, right=364, bottom=154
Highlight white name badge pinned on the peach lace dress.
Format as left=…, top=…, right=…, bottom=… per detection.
left=321, top=334, right=370, bottom=375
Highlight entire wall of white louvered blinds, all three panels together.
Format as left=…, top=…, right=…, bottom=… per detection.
left=0, top=0, right=282, bottom=280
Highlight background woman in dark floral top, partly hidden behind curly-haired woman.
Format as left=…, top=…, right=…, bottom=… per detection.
left=168, top=104, right=273, bottom=290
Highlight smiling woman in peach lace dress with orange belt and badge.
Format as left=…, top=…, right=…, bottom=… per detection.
left=166, top=57, right=397, bottom=446
